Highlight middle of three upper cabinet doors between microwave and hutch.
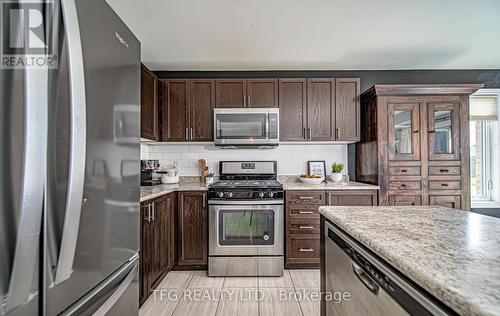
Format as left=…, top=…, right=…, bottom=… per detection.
left=307, top=78, right=335, bottom=141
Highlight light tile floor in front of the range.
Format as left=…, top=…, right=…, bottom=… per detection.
left=139, top=270, right=320, bottom=316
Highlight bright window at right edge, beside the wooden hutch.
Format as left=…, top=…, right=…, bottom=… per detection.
left=470, top=90, right=500, bottom=207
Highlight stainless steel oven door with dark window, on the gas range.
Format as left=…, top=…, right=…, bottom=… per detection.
left=208, top=202, right=284, bottom=256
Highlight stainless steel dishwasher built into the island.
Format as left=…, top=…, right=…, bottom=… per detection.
left=325, top=222, right=453, bottom=316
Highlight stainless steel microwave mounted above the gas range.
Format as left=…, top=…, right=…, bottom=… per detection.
left=214, top=108, right=279, bottom=148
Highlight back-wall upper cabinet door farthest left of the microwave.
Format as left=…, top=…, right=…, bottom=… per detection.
left=162, top=80, right=190, bottom=142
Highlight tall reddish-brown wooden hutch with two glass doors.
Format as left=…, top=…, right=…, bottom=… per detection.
left=356, top=84, right=482, bottom=210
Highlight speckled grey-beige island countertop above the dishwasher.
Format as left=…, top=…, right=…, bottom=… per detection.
left=319, top=206, right=500, bottom=315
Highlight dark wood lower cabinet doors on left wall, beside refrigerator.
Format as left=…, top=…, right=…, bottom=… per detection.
left=139, top=193, right=177, bottom=304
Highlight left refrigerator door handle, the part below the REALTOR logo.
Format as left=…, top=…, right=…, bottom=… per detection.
left=5, top=69, right=48, bottom=313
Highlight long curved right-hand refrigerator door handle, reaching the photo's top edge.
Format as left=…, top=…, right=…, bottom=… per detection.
left=54, top=0, right=87, bottom=284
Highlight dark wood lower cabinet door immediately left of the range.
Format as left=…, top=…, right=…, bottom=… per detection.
left=177, top=191, right=208, bottom=266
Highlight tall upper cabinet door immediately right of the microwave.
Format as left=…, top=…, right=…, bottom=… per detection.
left=279, top=78, right=307, bottom=141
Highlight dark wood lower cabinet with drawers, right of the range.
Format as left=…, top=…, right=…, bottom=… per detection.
left=285, top=190, right=378, bottom=269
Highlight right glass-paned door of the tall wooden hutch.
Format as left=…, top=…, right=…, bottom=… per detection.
left=427, top=102, right=460, bottom=160
